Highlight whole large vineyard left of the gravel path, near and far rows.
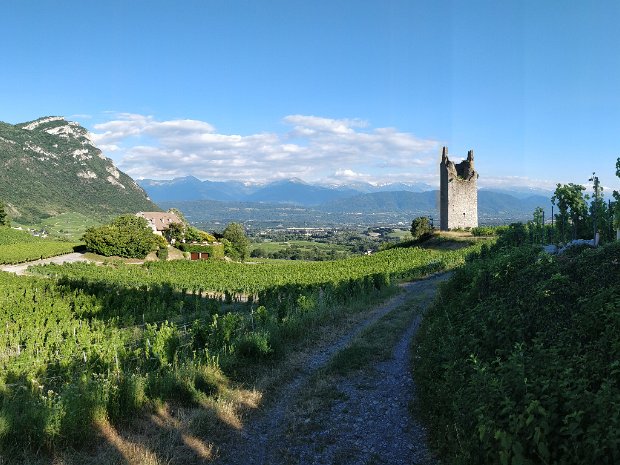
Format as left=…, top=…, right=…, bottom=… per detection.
left=0, top=241, right=480, bottom=458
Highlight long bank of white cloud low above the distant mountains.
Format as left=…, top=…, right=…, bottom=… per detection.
left=92, top=113, right=439, bottom=182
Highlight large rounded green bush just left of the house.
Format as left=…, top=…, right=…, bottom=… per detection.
left=82, top=215, right=158, bottom=258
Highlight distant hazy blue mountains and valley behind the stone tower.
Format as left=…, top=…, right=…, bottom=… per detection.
left=145, top=177, right=551, bottom=228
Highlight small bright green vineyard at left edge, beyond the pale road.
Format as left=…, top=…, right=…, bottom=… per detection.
left=0, top=227, right=77, bottom=265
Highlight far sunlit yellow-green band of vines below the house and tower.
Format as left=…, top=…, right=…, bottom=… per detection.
left=35, top=248, right=470, bottom=295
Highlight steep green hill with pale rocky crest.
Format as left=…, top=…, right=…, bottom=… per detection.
left=0, top=116, right=159, bottom=223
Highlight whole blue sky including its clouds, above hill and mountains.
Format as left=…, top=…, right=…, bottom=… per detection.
left=0, top=0, right=620, bottom=188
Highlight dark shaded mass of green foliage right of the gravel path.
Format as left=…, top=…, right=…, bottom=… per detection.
left=414, top=241, right=620, bottom=465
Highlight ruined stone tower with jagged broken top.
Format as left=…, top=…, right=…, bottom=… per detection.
left=439, top=147, right=478, bottom=231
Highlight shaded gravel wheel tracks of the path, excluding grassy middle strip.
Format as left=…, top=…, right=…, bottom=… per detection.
left=218, top=275, right=446, bottom=465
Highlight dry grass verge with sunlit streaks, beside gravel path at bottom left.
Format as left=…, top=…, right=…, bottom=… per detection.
left=0, top=358, right=261, bottom=465
